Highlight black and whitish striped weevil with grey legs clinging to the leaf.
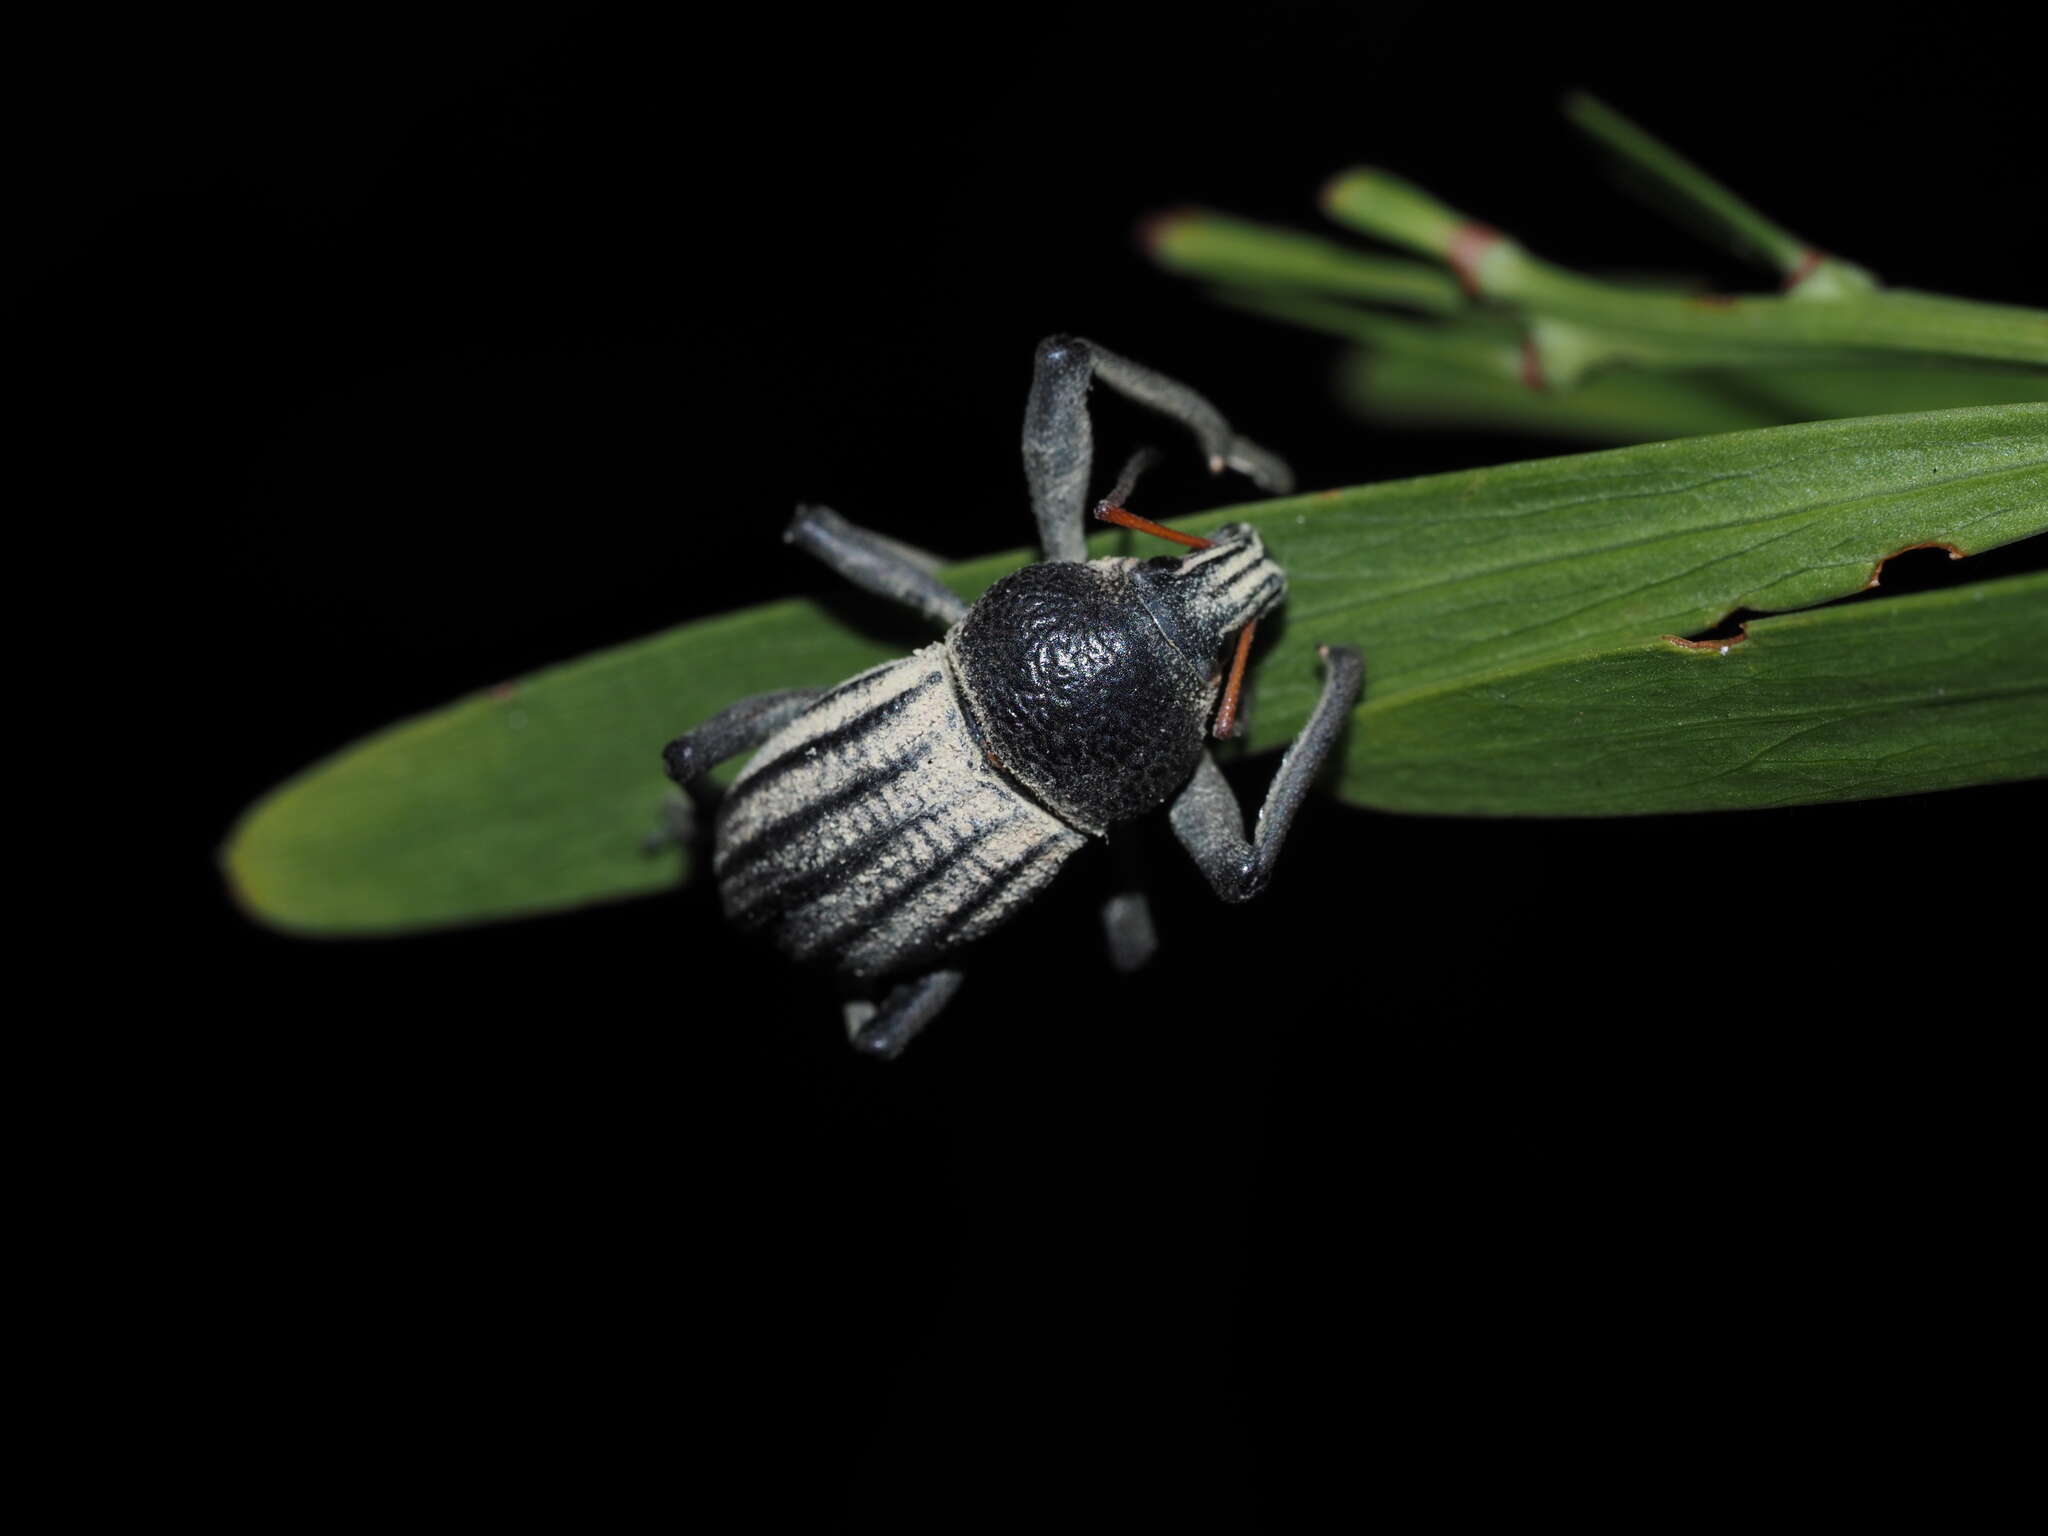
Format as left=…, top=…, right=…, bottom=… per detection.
left=662, top=336, right=1364, bottom=1057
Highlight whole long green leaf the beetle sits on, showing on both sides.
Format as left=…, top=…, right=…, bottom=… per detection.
left=223, top=406, right=2048, bottom=934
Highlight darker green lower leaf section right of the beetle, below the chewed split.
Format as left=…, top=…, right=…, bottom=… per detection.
left=1343, top=573, right=2048, bottom=815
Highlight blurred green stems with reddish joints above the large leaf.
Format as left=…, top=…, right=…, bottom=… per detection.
left=1143, top=92, right=2048, bottom=442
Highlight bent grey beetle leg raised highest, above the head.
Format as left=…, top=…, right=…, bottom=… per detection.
left=1024, top=336, right=1294, bottom=561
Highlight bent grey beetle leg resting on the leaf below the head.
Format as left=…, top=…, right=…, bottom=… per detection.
left=1171, top=645, right=1364, bottom=901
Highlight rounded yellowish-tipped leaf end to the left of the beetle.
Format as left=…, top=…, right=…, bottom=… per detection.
left=223, top=602, right=913, bottom=934
